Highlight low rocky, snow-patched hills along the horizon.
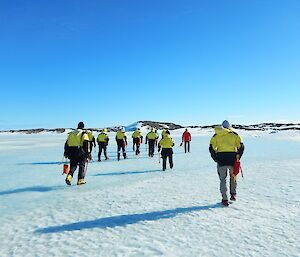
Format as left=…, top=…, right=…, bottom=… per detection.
left=0, top=121, right=300, bottom=134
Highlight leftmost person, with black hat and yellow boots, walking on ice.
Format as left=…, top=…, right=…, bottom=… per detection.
left=64, top=122, right=89, bottom=185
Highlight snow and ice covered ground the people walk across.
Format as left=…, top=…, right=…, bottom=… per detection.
left=0, top=129, right=300, bottom=257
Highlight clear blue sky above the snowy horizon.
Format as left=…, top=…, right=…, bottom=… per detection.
left=0, top=0, right=300, bottom=130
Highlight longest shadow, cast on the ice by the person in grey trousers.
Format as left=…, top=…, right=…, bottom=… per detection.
left=35, top=203, right=222, bottom=234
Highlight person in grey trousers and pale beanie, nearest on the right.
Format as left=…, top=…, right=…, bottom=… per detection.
left=209, top=120, right=245, bottom=206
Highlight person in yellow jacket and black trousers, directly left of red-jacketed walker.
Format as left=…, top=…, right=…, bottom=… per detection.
left=158, top=130, right=175, bottom=171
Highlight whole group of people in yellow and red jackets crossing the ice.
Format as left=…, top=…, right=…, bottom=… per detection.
left=64, top=120, right=244, bottom=206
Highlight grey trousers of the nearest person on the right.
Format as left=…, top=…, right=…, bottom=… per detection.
left=217, top=164, right=236, bottom=200
